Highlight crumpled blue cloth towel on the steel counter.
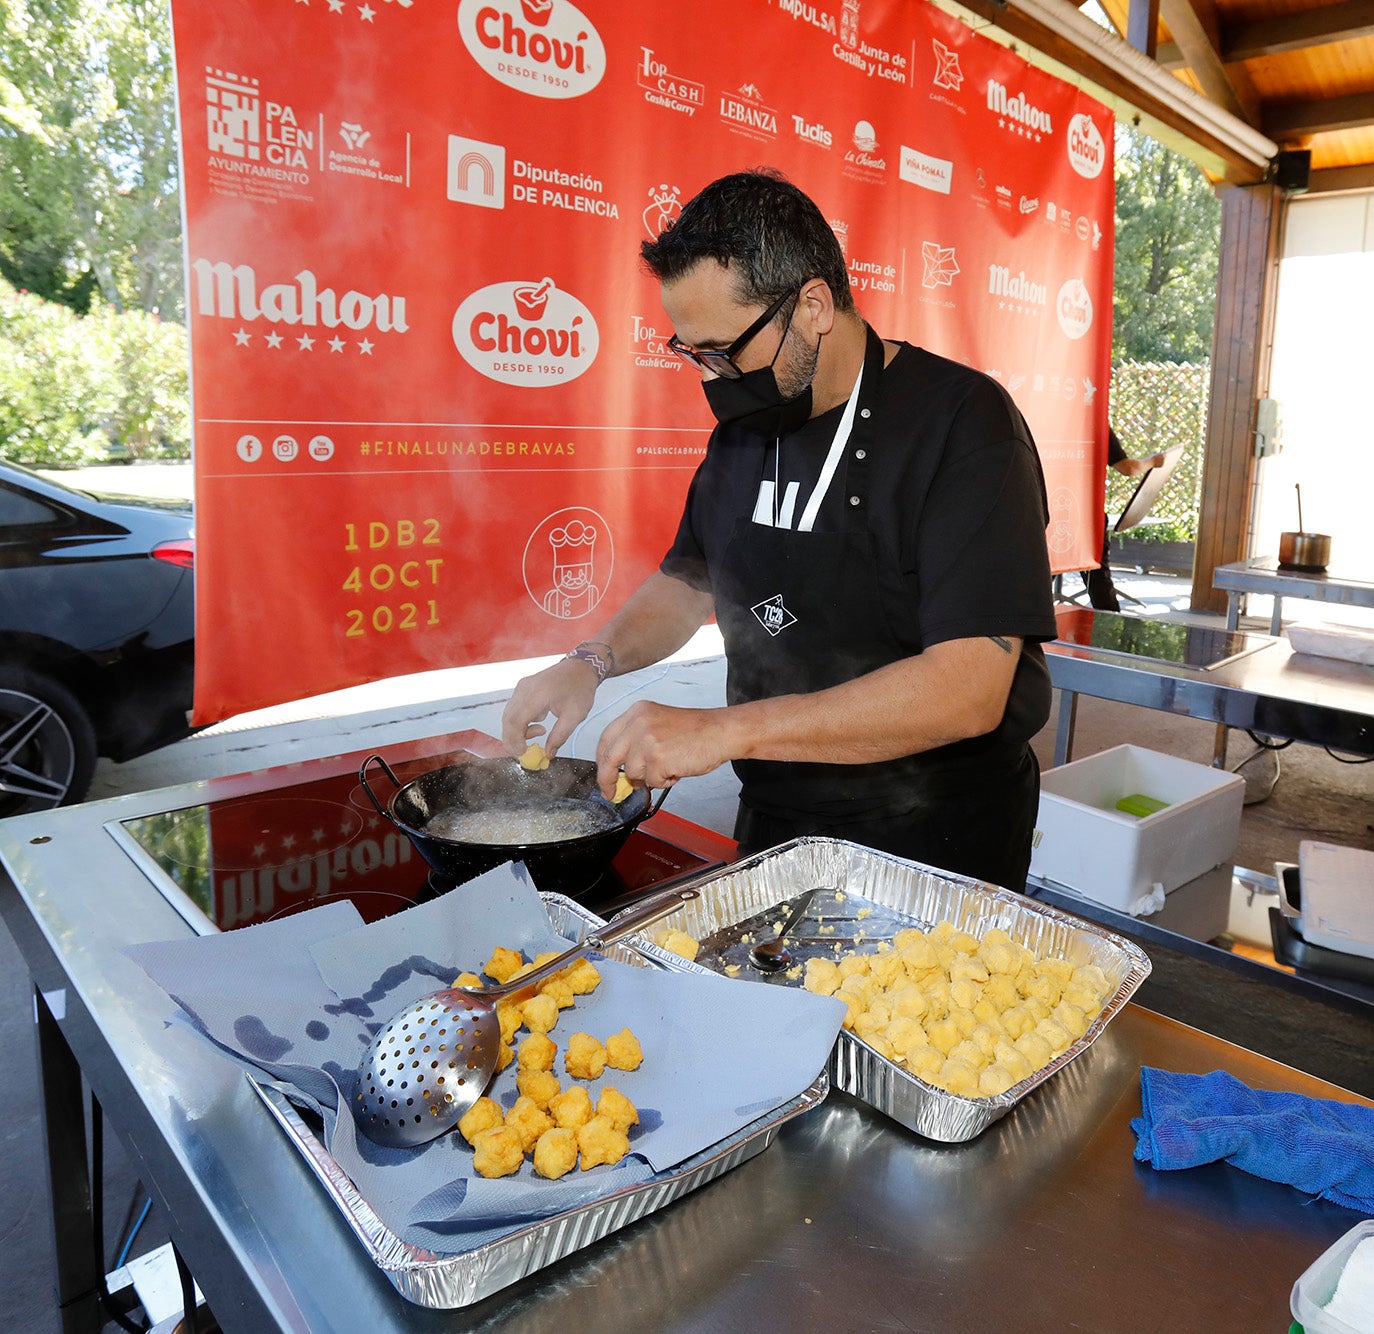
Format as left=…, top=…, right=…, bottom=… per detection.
left=1131, top=1066, right=1374, bottom=1214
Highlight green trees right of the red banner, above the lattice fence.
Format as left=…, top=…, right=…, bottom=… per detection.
left=1112, top=124, right=1221, bottom=361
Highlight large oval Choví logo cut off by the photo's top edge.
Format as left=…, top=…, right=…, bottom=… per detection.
left=458, top=0, right=606, bottom=98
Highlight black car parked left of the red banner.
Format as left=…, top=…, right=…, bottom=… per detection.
left=0, top=463, right=195, bottom=816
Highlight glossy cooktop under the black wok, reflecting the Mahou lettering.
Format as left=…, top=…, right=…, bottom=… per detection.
left=106, top=751, right=720, bottom=934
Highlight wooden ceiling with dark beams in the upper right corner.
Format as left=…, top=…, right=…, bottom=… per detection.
left=1099, top=0, right=1374, bottom=190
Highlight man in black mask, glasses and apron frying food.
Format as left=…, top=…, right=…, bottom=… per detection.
left=503, top=170, right=1055, bottom=889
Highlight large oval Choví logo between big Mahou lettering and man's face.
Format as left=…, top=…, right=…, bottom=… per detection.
left=453, top=278, right=599, bottom=389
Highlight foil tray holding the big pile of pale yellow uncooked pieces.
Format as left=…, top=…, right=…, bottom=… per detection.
left=629, top=838, right=1150, bottom=1143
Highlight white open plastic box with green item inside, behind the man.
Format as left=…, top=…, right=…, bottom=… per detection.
left=1031, top=746, right=1245, bottom=916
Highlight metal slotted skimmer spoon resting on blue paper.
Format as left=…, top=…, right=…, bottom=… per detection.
left=353, top=885, right=699, bottom=1149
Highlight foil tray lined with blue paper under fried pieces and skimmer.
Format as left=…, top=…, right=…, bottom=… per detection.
left=249, top=894, right=830, bottom=1309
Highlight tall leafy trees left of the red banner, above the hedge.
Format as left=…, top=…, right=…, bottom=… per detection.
left=0, top=0, right=183, bottom=319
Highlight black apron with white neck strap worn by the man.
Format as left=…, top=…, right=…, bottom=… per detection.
left=712, top=328, right=1039, bottom=890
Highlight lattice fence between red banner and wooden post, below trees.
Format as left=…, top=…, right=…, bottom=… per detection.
left=1106, top=361, right=1210, bottom=543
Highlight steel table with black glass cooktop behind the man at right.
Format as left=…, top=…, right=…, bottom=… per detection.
left=1044, top=607, right=1374, bottom=765
